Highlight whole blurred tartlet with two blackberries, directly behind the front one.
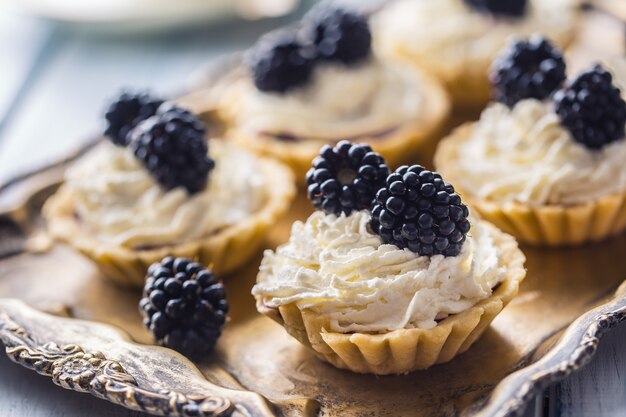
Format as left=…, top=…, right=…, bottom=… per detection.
left=189, top=7, right=449, bottom=178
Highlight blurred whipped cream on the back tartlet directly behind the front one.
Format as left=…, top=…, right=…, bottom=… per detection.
left=235, top=58, right=422, bottom=141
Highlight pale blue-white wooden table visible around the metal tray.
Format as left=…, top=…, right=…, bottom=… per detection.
left=0, top=6, right=626, bottom=417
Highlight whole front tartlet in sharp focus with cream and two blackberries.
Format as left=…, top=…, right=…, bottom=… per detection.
left=252, top=142, right=525, bottom=375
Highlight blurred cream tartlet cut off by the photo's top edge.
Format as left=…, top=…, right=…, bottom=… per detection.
left=374, top=0, right=580, bottom=106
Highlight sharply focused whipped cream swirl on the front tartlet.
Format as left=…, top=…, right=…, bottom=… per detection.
left=252, top=211, right=506, bottom=333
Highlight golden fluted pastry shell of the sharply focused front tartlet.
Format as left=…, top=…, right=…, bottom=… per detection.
left=252, top=224, right=526, bottom=375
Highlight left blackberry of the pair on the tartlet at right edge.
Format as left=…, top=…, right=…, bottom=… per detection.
left=490, top=36, right=565, bottom=107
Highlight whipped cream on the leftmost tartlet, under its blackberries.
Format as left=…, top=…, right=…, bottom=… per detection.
left=64, top=141, right=267, bottom=249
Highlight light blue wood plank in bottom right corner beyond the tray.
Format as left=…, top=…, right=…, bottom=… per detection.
left=555, top=324, right=626, bottom=417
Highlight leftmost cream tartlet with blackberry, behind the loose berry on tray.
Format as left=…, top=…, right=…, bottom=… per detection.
left=44, top=98, right=295, bottom=286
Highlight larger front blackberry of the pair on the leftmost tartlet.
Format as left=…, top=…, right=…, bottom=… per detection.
left=130, top=103, right=215, bottom=194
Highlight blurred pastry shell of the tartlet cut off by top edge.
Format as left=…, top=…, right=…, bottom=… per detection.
left=376, top=0, right=577, bottom=109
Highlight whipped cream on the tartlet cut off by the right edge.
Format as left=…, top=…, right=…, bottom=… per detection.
left=451, top=99, right=626, bottom=205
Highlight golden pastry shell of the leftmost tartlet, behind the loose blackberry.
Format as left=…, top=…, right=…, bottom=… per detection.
left=43, top=140, right=296, bottom=287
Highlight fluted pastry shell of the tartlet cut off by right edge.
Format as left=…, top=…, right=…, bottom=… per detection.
left=435, top=123, right=626, bottom=246
